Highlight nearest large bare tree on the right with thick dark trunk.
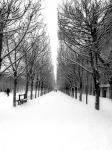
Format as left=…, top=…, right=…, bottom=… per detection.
left=58, top=0, right=108, bottom=110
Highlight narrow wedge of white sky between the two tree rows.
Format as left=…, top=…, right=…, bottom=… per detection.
left=44, top=0, right=61, bottom=79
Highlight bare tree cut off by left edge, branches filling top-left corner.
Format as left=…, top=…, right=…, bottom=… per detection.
left=0, top=0, right=31, bottom=68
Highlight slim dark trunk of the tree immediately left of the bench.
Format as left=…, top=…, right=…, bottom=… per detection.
left=13, top=71, right=17, bottom=107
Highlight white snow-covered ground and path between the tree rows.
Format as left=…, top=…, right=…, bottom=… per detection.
left=0, top=92, right=112, bottom=150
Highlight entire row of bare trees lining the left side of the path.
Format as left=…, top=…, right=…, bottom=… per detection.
left=0, top=0, right=54, bottom=106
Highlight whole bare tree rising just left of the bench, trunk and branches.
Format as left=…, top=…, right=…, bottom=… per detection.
left=2, top=2, right=40, bottom=106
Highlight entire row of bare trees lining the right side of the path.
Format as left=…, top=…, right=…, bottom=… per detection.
left=58, top=0, right=112, bottom=110
